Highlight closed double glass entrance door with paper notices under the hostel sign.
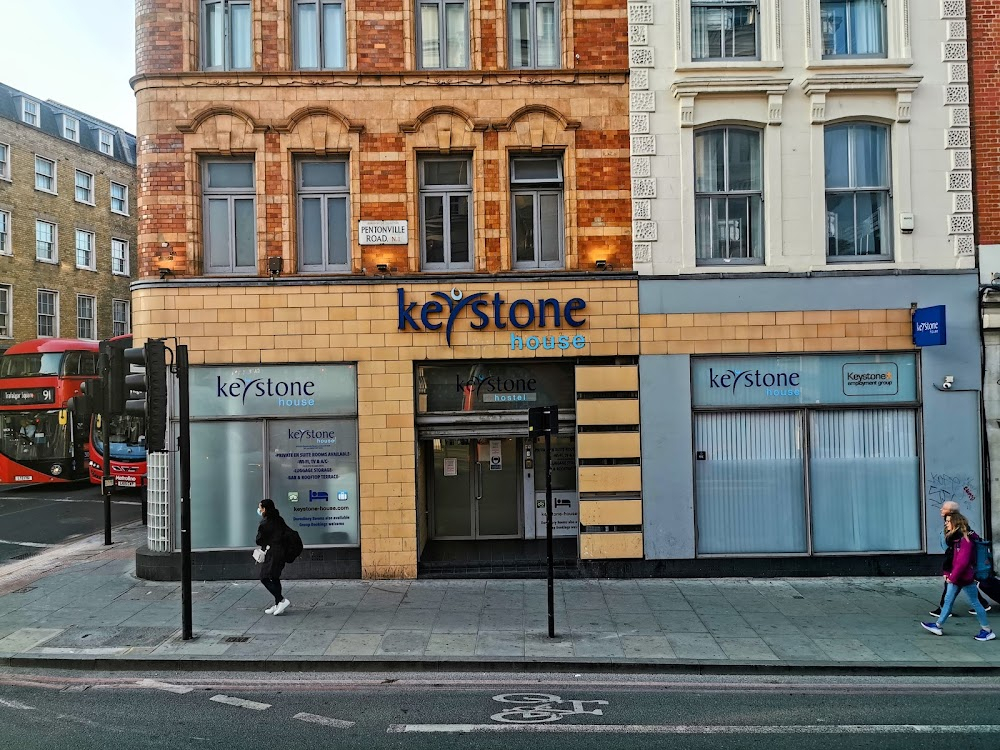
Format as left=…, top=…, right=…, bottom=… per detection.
left=430, top=438, right=523, bottom=539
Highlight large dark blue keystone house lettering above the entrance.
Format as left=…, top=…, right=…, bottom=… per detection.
left=396, top=288, right=587, bottom=349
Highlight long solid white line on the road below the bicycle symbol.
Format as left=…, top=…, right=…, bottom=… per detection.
left=387, top=724, right=1000, bottom=734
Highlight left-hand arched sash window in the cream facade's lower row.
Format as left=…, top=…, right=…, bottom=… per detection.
left=694, top=127, right=764, bottom=265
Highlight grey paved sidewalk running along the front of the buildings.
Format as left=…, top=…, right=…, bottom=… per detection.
left=0, top=525, right=1000, bottom=672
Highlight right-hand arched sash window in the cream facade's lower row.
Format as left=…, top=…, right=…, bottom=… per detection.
left=825, top=123, right=892, bottom=261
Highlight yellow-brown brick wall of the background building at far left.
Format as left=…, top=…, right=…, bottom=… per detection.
left=0, top=99, right=137, bottom=349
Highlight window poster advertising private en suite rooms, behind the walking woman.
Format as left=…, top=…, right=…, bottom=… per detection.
left=267, top=419, right=359, bottom=546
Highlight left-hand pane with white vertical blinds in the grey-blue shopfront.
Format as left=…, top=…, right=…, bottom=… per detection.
left=695, top=412, right=807, bottom=554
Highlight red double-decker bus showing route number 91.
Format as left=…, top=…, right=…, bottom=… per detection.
left=0, top=339, right=99, bottom=484
